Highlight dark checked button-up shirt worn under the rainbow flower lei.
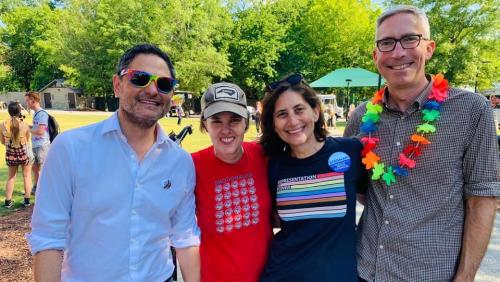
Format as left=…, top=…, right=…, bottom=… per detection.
left=344, top=79, right=500, bottom=281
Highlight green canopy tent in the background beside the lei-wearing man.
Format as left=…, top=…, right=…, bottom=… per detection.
left=309, top=68, right=385, bottom=107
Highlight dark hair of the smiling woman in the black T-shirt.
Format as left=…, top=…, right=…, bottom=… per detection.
left=259, top=79, right=327, bottom=157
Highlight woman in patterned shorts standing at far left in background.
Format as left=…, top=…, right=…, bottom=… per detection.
left=0, top=102, right=33, bottom=208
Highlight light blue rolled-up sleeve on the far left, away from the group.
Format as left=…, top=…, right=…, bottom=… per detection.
left=26, top=134, right=73, bottom=254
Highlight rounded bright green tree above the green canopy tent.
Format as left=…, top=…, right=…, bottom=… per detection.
left=278, top=0, right=376, bottom=80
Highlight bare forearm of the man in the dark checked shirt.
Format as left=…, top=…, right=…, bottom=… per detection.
left=454, top=196, right=496, bottom=282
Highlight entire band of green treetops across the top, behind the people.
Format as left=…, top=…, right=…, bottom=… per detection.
left=0, top=0, right=500, bottom=97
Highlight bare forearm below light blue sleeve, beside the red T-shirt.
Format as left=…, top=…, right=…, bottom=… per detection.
left=175, top=246, right=200, bottom=282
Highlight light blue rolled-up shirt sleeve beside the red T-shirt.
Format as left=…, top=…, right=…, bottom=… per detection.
left=170, top=161, right=200, bottom=248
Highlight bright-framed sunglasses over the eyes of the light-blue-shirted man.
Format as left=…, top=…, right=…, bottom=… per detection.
left=119, top=69, right=177, bottom=94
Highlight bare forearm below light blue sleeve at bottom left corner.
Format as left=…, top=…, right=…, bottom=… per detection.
left=34, top=250, right=62, bottom=282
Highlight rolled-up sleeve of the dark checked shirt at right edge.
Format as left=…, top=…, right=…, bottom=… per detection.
left=464, top=99, right=500, bottom=197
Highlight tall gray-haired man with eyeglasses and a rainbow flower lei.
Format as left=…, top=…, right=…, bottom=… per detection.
left=344, top=6, right=500, bottom=281
